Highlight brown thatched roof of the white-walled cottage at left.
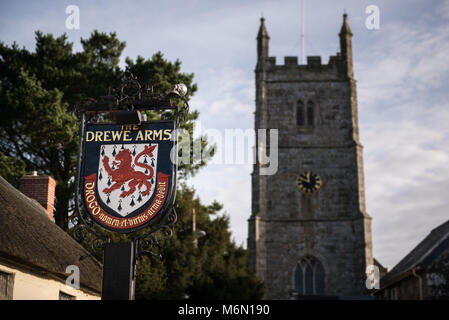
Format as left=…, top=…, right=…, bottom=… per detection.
left=0, top=176, right=102, bottom=293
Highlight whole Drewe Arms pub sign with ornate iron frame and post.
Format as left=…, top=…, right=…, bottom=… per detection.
left=71, top=75, right=188, bottom=300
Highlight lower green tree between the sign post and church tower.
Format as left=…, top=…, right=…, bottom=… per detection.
left=136, top=185, right=265, bottom=299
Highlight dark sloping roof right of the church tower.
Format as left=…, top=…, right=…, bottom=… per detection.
left=380, top=220, right=449, bottom=287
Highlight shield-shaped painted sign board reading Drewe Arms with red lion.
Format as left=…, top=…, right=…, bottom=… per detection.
left=81, top=121, right=175, bottom=232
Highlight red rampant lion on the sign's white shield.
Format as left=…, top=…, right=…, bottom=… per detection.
left=103, top=146, right=156, bottom=198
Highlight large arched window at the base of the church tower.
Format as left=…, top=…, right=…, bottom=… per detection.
left=295, top=256, right=324, bottom=296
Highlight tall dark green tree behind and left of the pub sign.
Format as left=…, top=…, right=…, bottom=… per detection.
left=0, top=31, right=208, bottom=230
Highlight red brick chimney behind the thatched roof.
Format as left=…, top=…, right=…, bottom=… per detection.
left=20, top=171, right=56, bottom=221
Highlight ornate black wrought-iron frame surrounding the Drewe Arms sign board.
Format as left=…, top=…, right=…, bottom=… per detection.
left=70, top=74, right=189, bottom=259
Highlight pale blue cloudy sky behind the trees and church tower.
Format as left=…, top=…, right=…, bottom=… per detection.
left=0, top=0, right=449, bottom=268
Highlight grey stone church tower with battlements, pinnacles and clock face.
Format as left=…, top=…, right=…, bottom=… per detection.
left=248, top=14, right=373, bottom=299
